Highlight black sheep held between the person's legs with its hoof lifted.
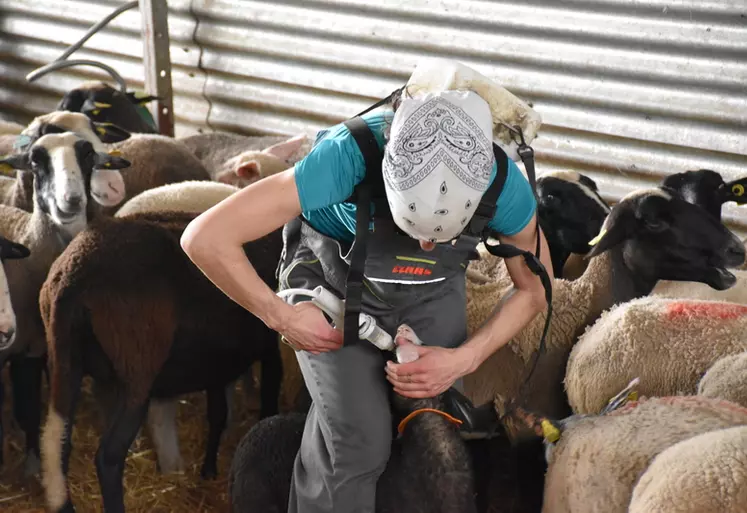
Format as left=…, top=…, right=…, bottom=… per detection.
left=228, top=325, right=544, bottom=513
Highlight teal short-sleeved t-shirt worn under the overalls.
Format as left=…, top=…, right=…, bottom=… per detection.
left=294, top=111, right=537, bottom=242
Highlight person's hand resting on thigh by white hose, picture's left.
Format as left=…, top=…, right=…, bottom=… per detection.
left=281, top=301, right=342, bottom=354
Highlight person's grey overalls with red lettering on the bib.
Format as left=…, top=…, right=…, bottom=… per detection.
left=279, top=215, right=470, bottom=513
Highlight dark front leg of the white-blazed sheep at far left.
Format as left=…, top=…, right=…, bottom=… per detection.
left=10, top=357, right=44, bottom=477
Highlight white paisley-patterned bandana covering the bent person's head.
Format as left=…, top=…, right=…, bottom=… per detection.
left=382, top=91, right=495, bottom=242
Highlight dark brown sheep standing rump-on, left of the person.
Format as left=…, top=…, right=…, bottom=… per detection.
left=39, top=212, right=282, bottom=513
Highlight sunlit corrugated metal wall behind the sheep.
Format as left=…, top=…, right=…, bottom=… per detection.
left=0, top=0, right=747, bottom=232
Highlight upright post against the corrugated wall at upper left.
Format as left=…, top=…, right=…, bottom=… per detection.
left=139, top=0, right=174, bottom=137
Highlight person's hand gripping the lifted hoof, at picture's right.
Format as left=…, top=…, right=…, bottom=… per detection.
left=386, top=341, right=472, bottom=399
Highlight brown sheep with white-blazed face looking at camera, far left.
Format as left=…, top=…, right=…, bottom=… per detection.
left=0, top=133, right=129, bottom=475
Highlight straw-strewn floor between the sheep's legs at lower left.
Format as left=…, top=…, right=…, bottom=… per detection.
left=0, top=371, right=268, bottom=513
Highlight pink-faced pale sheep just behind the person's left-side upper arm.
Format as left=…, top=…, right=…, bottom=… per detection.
left=179, top=133, right=310, bottom=188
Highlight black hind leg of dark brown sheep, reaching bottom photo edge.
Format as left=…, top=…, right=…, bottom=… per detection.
left=96, top=400, right=148, bottom=513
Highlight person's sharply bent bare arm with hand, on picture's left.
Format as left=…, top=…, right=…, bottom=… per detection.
left=181, top=168, right=342, bottom=352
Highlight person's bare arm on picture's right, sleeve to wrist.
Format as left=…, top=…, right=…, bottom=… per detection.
left=460, top=214, right=553, bottom=372
